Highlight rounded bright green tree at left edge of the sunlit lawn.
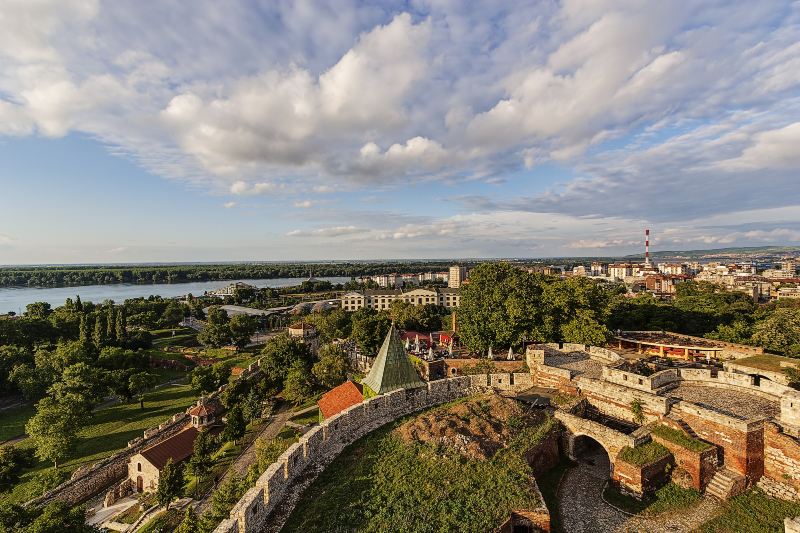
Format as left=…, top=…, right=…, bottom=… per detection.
left=25, top=397, right=85, bottom=468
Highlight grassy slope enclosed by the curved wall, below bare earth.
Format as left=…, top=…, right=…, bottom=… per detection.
left=284, top=404, right=551, bottom=532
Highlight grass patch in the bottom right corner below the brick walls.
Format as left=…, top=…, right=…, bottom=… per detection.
left=700, top=488, right=800, bottom=533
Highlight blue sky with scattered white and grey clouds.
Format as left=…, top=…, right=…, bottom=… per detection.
left=0, top=0, right=800, bottom=264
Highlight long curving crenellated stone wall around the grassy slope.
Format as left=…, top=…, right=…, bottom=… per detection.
left=215, top=375, right=488, bottom=533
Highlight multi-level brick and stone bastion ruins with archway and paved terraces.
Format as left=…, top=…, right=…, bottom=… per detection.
left=526, top=344, right=800, bottom=500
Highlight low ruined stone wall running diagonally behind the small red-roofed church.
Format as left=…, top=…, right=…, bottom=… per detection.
left=25, top=361, right=259, bottom=506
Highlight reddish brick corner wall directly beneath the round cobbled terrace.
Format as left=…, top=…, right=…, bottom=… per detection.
left=673, top=402, right=764, bottom=485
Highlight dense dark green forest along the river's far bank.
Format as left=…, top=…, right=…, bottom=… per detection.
left=0, top=261, right=476, bottom=287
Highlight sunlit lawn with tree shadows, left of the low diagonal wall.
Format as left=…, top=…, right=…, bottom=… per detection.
left=0, top=385, right=197, bottom=503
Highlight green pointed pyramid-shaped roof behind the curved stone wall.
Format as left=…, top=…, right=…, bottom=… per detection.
left=361, top=325, right=426, bottom=394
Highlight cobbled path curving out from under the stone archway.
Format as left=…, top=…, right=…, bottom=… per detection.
left=558, top=451, right=719, bottom=533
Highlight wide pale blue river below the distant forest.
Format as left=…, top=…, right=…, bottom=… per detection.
left=0, top=277, right=350, bottom=313
